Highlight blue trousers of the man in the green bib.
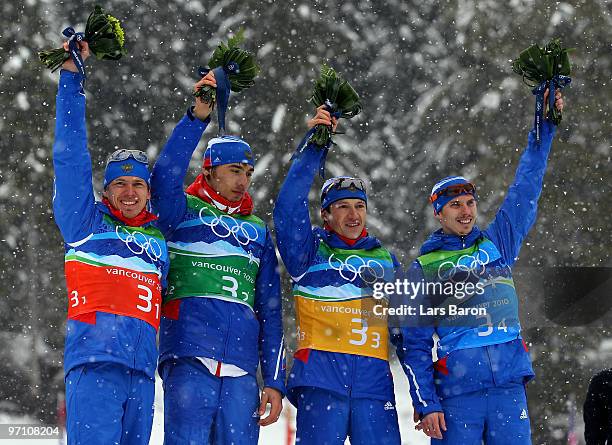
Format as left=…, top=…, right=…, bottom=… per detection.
left=161, top=358, right=259, bottom=445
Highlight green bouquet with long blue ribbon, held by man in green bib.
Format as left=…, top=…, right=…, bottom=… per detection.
left=194, top=30, right=261, bottom=135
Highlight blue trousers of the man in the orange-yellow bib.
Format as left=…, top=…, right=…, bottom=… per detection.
left=296, top=386, right=401, bottom=445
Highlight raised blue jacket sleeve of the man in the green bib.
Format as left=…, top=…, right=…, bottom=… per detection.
left=151, top=112, right=210, bottom=236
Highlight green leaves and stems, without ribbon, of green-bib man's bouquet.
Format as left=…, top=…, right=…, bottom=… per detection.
left=193, top=29, right=261, bottom=103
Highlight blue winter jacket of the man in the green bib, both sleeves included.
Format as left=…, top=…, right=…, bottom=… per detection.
left=151, top=110, right=285, bottom=394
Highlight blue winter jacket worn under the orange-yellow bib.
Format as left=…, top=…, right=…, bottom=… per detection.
left=274, top=130, right=400, bottom=406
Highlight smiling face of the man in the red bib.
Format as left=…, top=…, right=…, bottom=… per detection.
left=104, top=176, right=151, bottom=218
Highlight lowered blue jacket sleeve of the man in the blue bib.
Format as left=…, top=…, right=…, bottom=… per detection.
left=391, top=261, right=442, bottom=417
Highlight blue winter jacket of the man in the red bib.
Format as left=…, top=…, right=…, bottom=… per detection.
left=53, top=70, right=169, bottom=378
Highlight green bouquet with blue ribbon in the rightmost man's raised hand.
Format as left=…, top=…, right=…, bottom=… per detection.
left=512, top=39, right=572, bottom=143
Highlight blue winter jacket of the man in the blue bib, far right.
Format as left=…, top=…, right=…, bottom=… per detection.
left=395, top=121, right=555, bottom=416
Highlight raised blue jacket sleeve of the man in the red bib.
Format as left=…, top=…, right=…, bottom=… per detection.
left=53, top=70, right=96, bottom=243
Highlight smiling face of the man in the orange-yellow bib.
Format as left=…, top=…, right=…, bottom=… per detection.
left=321, top=198, right=367, bottom=239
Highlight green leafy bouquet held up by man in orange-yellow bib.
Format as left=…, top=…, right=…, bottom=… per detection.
left=310, top=64, right=362, bottom=147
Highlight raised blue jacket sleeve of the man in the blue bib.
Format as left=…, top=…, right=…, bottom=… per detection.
left=485, top=120, right=556, bottom=266
